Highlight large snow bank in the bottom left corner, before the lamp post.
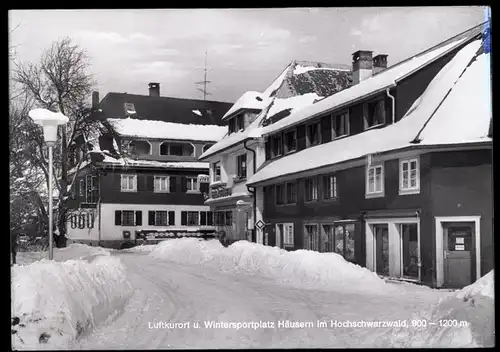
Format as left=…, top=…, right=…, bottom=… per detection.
left=11, top=252, right=133, bottom=349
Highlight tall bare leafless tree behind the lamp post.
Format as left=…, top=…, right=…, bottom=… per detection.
left=13, top=38, right=95, bottom=247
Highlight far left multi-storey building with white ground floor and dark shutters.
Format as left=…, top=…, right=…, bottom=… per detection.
left=67, top=83, right=232, bottom=248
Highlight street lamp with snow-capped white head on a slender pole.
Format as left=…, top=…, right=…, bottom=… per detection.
left=29, top=109, right=69, bottom=260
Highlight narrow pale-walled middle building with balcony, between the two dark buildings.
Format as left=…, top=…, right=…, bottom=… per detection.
left=199, top=61, right=351, bottom=241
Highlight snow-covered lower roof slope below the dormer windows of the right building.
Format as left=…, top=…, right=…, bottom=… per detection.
left=247, top=40, right=492, bottom=185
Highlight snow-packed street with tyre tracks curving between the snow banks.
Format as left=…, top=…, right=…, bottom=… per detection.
left=75, top=252, right=446, bottom=349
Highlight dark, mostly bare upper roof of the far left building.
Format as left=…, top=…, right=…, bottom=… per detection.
left=99, top=92, right=233, bottom=126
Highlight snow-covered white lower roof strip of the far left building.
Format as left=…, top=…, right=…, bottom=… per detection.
left=107, top=118, right=227, bottom=142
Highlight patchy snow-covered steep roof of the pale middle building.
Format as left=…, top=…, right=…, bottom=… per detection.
left=200, top=60, right=352, bottom=160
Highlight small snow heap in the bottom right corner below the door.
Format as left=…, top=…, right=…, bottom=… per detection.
left=377, top=270, right=495, bottom=348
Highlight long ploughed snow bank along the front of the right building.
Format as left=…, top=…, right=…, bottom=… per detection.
left=149, top=238, right=385, bottom=291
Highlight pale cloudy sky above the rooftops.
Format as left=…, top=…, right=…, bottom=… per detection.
left=9, top=7, right=485, bottom=102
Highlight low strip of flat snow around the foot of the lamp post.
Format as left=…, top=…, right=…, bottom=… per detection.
left=16, top=243, right=112, bottom=265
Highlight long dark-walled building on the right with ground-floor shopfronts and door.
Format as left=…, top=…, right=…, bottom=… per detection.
left=246, top=24, right=493, bottom=287
